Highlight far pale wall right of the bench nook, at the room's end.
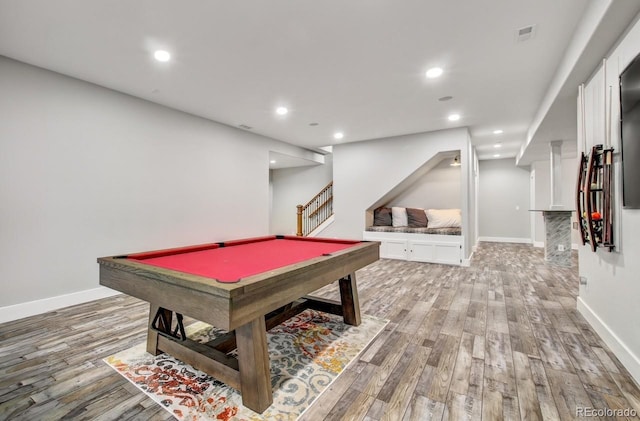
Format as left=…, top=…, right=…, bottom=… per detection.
left=478, top=158, right=531, bottom=243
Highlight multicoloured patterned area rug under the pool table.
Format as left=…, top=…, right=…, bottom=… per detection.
left=104, top=310, right=388, bottom=421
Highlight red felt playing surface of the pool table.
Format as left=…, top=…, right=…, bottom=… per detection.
left=127, top=236, right=360, bottom=282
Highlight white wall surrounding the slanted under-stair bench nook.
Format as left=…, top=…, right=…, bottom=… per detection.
left=321, top=128, right=475, bottom=256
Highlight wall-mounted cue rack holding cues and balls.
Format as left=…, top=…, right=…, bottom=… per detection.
left=576, top=145, right=615, bottom=252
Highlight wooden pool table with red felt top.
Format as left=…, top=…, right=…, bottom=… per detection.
left=98, top=236, right=380, bottom=413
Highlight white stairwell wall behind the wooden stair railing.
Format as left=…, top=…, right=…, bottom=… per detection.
left=269, top=155, right=333, bottom=235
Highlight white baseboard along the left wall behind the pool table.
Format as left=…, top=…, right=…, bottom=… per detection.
left=0, top=287, right=120, bottom=323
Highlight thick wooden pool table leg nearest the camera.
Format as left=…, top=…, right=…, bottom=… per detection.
left=236, top=316, right=273, bottom=413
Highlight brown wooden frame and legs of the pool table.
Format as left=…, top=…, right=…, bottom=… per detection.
left=98, top=241, right=380, bottom=413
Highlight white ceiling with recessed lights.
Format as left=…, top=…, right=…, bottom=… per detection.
left=0, top=0, right=640, bottom=164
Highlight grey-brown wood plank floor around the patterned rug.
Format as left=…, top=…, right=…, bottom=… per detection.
left=0, top=243, right=640, bottom=420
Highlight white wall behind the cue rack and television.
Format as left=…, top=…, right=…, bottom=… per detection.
left=578, top=13, right=640, bottom=383
